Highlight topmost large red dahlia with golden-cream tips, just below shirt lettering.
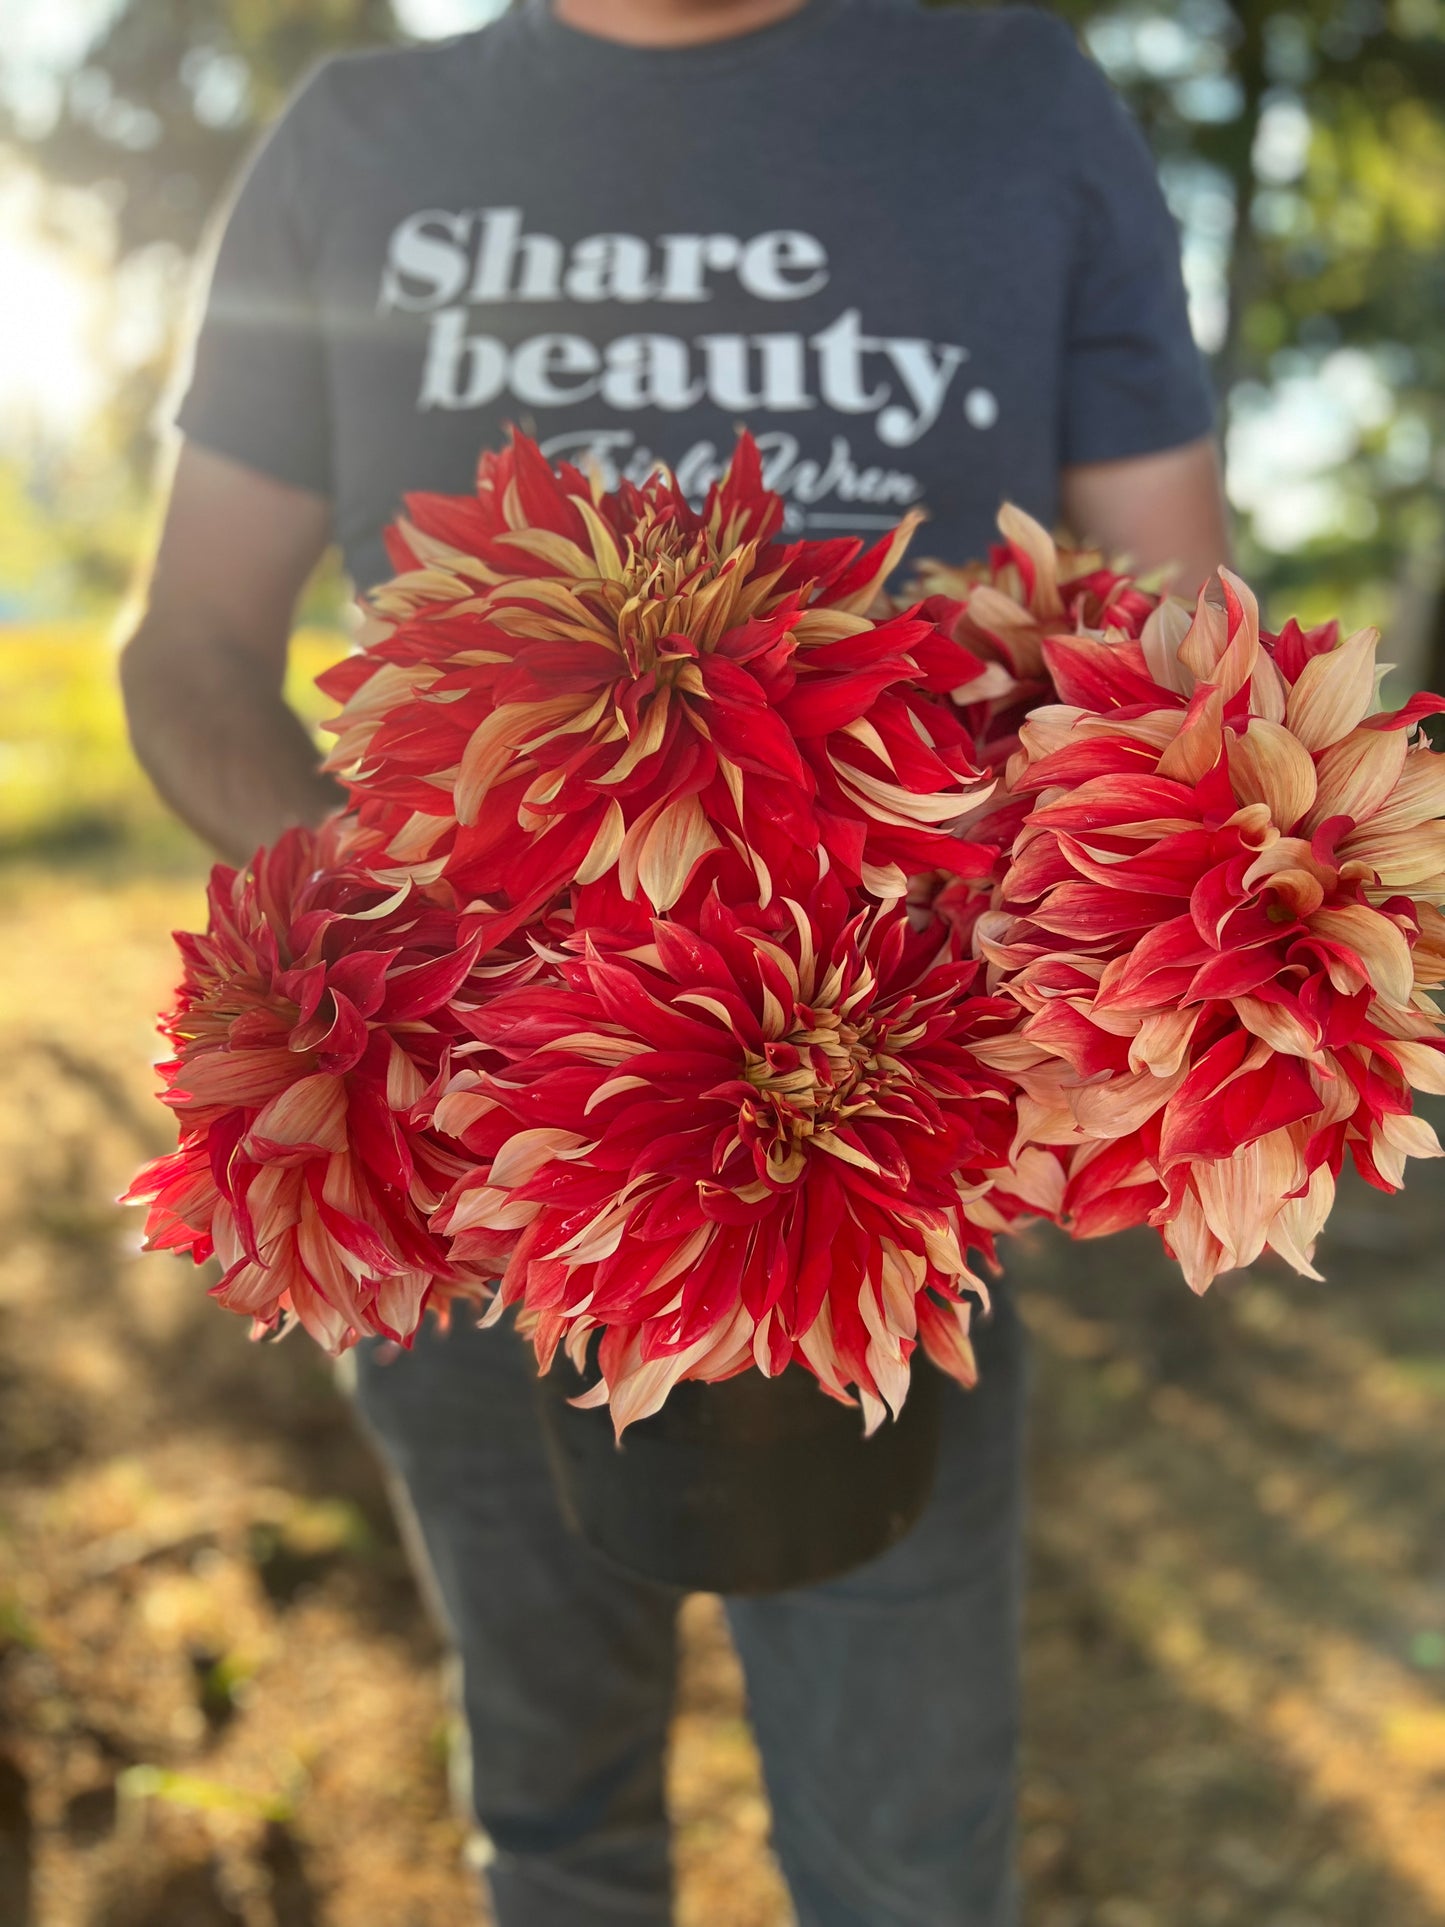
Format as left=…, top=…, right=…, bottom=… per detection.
left=322, top=436, right=988, bottom=942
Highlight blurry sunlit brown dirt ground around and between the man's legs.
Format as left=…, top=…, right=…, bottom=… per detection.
left=0, top=871, right=1445, bottom=1927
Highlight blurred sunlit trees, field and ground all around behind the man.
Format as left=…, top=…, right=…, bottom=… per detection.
left=0, top=0, right=1445, bottom=1927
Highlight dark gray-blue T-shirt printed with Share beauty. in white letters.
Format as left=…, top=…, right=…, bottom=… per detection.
left=177, top=0, right=1214, bottom=584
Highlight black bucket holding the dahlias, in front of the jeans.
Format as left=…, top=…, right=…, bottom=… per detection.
left=538, top=1351, right=942, bottom=1594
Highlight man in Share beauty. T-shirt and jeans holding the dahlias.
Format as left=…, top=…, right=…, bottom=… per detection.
left=121, top=0, right=1227, bottom=1927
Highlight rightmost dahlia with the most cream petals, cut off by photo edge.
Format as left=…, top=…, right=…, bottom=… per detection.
left=975, top=570, right=1445, bottom=1289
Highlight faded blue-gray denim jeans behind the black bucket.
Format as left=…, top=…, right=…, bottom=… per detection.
left=356, top=1293, right=1025, bottom=1927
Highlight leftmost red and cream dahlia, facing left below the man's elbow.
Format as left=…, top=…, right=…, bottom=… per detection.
left=127, top=821, right=528, bottom=1351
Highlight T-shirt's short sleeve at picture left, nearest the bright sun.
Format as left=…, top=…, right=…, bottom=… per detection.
left=175, top=72, right=331, bottom=495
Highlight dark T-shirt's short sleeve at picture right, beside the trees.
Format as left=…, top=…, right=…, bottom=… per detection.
left=1060, top=35, right=1214, bottom=466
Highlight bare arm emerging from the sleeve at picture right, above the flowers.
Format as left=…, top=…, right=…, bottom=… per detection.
left=1060, top=436, right=1231, bottom=601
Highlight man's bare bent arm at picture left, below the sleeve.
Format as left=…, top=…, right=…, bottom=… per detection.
left=121, top=441, right=341, bottom=863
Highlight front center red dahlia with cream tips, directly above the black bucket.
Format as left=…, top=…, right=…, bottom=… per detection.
left=432, top=875, right=1015, bottom=1432
